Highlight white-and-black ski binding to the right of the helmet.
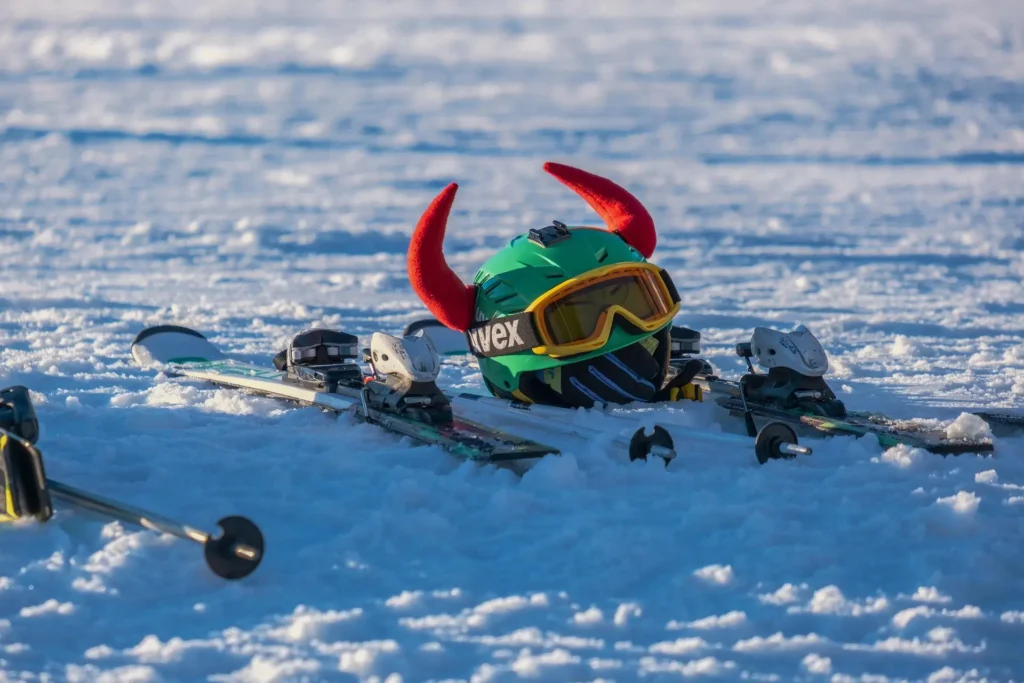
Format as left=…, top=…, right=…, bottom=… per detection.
left=736, top=325, right=846, bottom=418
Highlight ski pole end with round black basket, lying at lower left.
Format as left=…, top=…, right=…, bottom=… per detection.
left=46, top=479, right=263, bottom=579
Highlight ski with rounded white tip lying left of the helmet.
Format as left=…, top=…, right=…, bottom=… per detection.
left=131, top=325, right=558, bottom=463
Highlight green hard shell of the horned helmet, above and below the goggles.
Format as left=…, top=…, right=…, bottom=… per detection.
left=473, top=226, right=671, bottom=394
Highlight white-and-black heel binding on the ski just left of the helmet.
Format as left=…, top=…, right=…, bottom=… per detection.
left=361, top=332, right=453, bottom=425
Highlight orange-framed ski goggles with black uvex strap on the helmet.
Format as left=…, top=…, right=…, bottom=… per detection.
left=466, top=263, right=680, bottom=357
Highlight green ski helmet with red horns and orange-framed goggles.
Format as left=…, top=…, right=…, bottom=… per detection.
left=408, top=163, right=679, bottom=407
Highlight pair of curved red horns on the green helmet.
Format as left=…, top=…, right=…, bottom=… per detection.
left=408, top=162, right=657, bottom=332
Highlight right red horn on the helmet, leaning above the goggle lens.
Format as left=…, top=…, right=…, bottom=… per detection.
left=544, top=162, right=657, bottom=258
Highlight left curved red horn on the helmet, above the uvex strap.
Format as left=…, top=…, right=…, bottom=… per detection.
left=407, top=182, right=476, bottom=332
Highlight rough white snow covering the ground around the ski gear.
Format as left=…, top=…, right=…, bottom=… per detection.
left=0, top=0, right=1024, bottom=683
